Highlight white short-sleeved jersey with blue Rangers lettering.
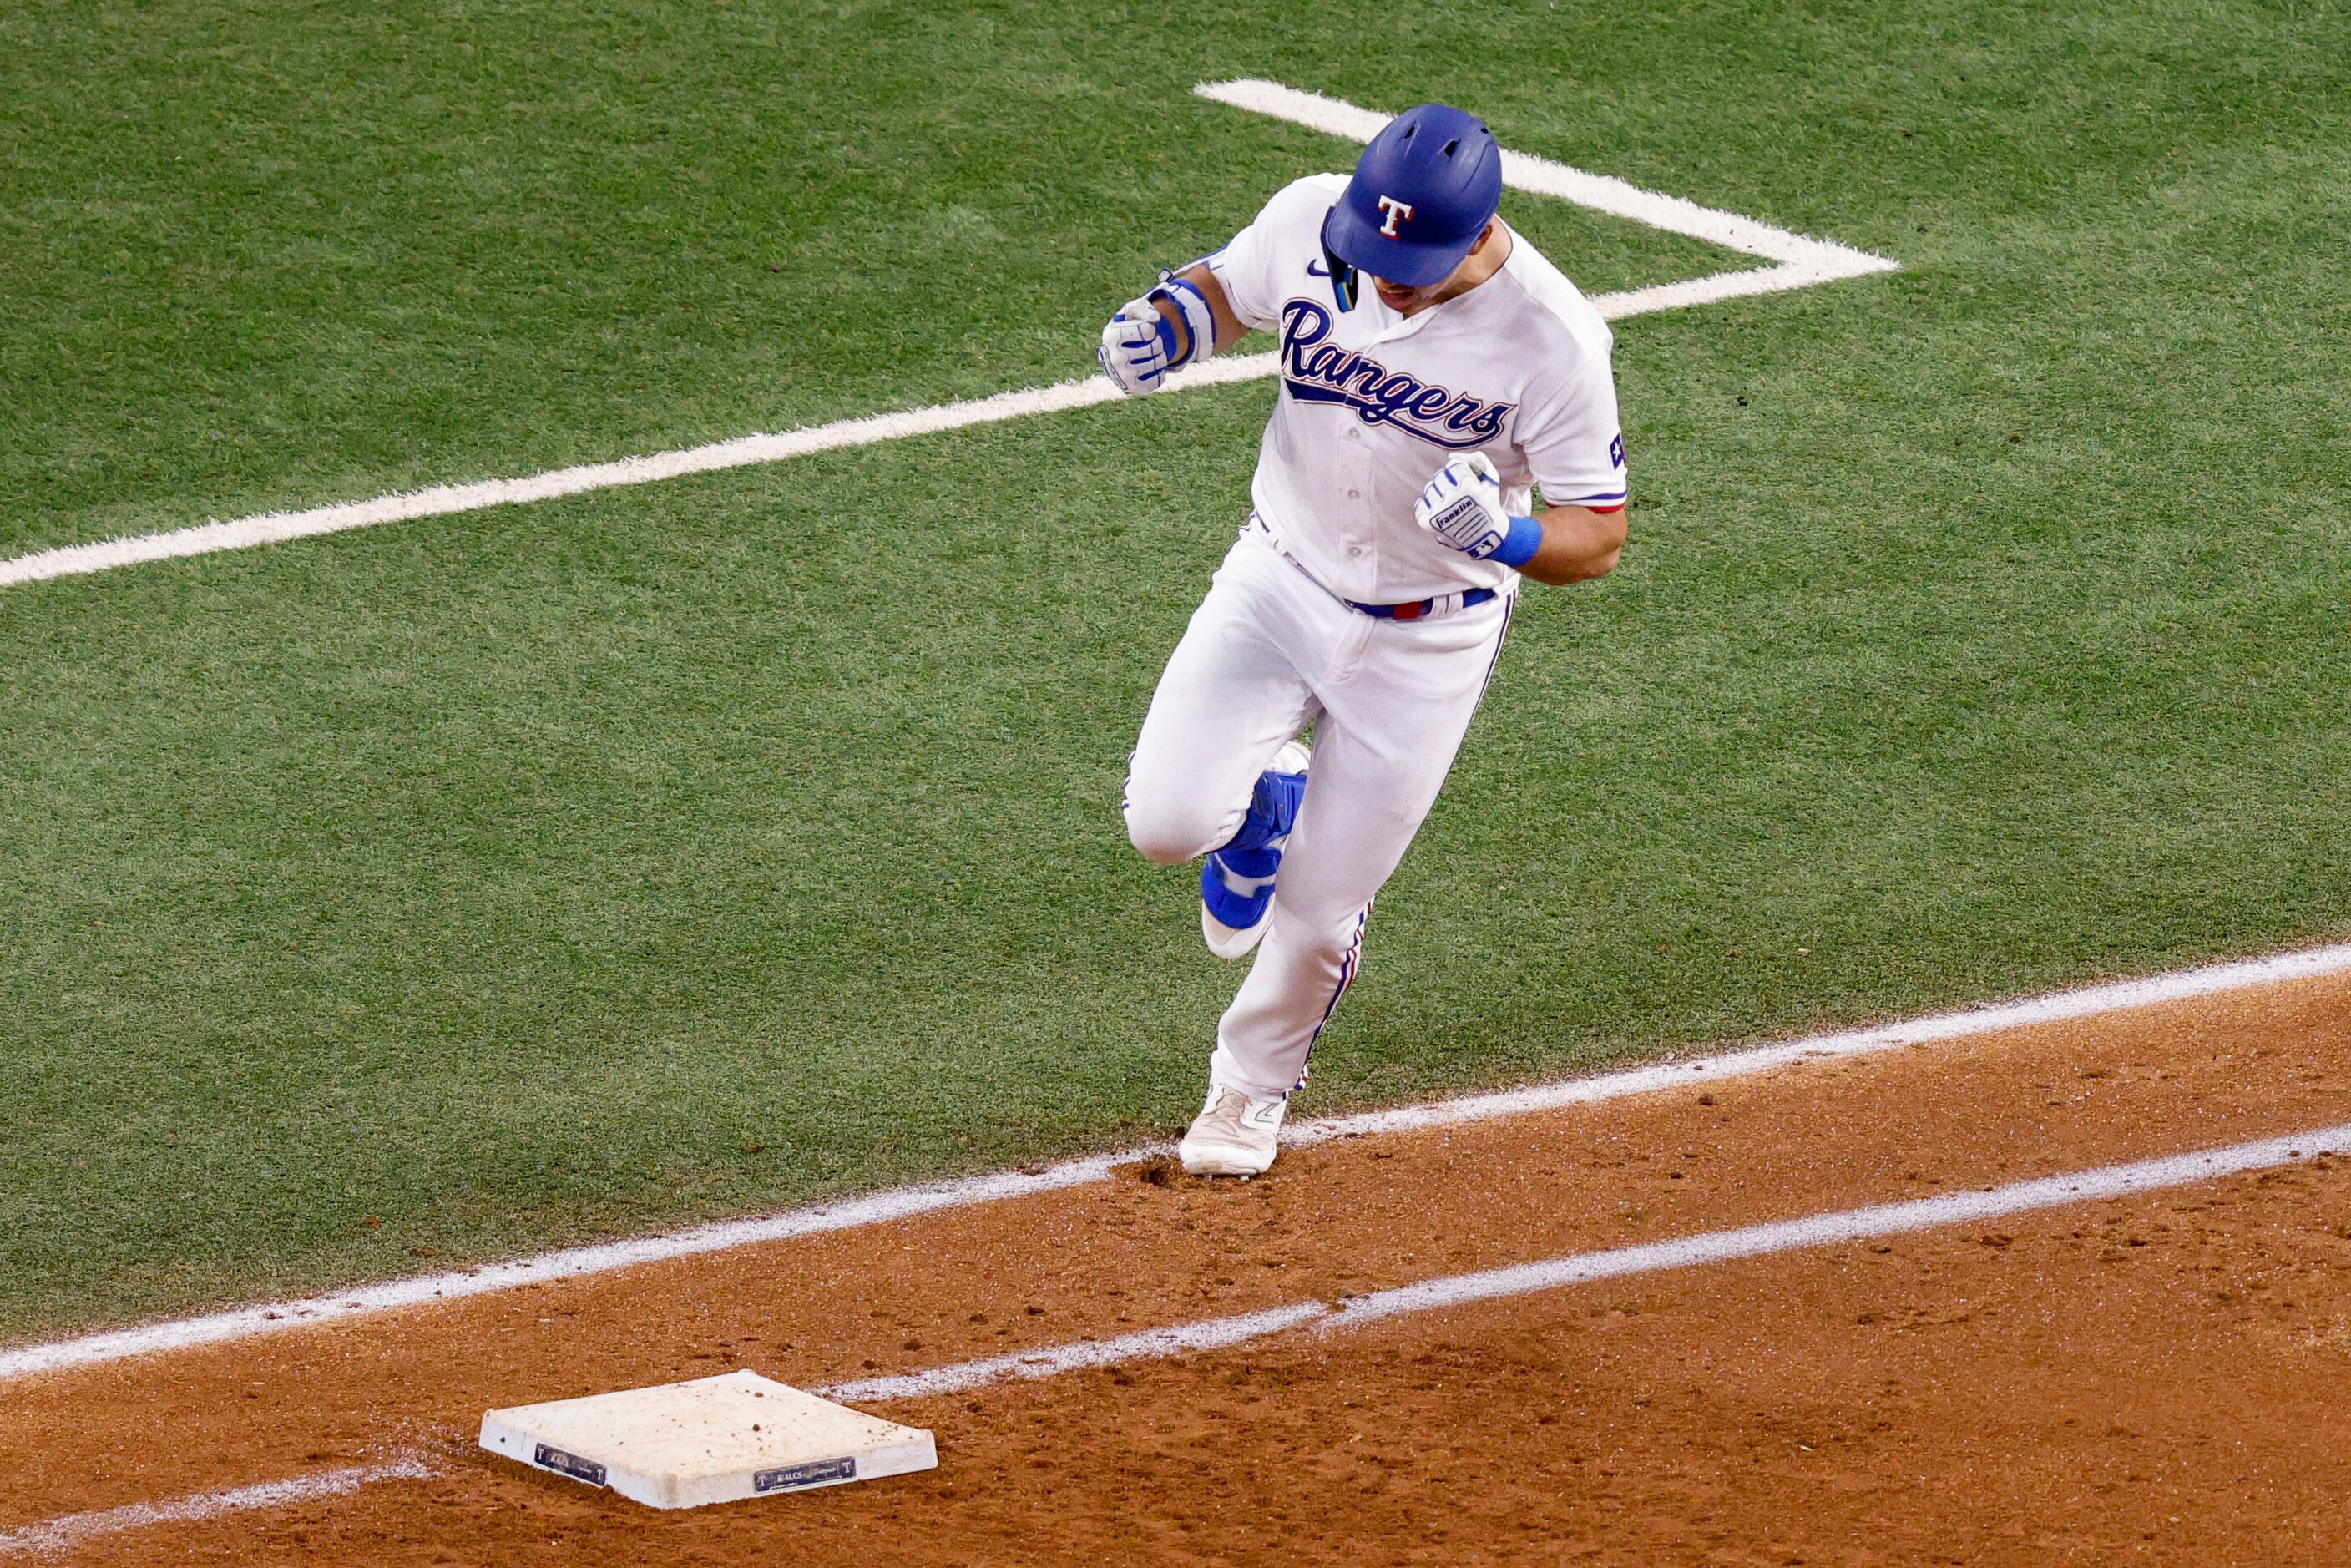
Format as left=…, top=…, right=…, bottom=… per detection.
left=1208, top=174, right=1627, bottom=604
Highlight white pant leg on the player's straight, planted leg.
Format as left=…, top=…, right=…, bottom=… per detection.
left=1211, top=602, right=1509, bottom=1109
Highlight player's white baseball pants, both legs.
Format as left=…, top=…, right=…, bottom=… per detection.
left=1126, top=522, right=1512, bottom=1100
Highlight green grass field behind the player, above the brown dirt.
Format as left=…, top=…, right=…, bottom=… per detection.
left=0, top=0, right=2351, bottom=1338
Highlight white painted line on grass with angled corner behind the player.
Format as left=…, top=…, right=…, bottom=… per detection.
left=0, top=80, right=1899, bottom=588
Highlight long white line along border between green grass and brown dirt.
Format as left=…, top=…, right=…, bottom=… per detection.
left=0, top=943, right=2351, bottom=1380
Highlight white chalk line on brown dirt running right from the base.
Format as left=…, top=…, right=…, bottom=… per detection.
left=821, top=1124, right=2351, bottom=1401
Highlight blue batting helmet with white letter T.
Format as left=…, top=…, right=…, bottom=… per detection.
left=1323, top=104, right=1502, bottom=303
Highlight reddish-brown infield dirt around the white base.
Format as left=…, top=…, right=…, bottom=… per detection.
left=0, top=978, right=2351, bottom=1565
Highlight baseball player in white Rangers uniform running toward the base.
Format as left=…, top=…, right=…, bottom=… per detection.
left=1100, top=104, right=1627, bottom=1176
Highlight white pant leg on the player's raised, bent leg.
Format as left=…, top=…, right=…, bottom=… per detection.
left=1126, top=536, right=1314, bottom=865
